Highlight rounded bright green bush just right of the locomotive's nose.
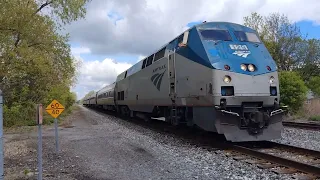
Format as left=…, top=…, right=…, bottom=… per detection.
left=279, top=71, right=308, bottom=113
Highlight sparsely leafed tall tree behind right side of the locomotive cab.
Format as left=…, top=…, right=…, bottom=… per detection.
left=244, top=13, right=303, bottom=71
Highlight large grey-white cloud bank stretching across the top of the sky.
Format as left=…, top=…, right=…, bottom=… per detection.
left=67, top=0, right=320, bottom=55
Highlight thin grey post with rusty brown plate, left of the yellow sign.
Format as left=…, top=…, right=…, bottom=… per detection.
left=36, top=104, right=43, bottom=180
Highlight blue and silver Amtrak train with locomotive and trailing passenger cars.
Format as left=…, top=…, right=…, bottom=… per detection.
left=83, top=22, right=285, bottom=142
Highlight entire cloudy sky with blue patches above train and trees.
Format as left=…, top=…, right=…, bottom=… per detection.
left=65, top=0, right=320, bottom=99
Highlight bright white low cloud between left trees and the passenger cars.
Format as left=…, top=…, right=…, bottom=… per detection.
left=73, top=57, right=132, bottom=98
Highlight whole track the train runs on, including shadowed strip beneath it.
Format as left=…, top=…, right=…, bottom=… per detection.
left=85, top=107, right=320, bottom=179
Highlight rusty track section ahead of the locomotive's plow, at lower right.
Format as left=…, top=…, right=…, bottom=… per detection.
left=225, top=141, right=320, bottom=179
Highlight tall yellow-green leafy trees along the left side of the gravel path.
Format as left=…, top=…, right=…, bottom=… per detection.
left=0, top=0, right=88, bottom=127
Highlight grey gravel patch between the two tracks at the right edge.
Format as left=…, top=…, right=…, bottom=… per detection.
left=272, top=127, right=320, bottom=151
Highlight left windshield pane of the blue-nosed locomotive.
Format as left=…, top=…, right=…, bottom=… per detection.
left=200, top=29, right=232, bottom=41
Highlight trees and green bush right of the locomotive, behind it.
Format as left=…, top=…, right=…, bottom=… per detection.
left=244, top=12, right=320, bottom=113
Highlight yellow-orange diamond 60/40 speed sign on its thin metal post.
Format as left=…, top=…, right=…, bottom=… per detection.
left=46, top=100, right=64, bottom=153
